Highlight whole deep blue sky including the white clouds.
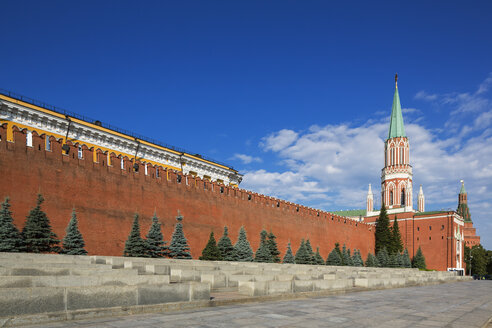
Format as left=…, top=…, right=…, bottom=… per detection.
left=0, top=1, right=492, bottom=249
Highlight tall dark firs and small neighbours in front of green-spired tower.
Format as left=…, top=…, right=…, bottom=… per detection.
left=374, top=203, right=426, bottom=270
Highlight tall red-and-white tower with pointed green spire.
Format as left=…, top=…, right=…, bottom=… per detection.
left=381, top=75, right=413, bottom=213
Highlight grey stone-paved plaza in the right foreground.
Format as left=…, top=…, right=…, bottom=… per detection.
left=31, top=281, right=492, bottom=328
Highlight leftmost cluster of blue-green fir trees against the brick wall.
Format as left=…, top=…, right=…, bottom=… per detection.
left=0, top=194, right=87, bottom=255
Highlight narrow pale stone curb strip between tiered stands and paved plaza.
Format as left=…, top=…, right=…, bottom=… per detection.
left=0, top=280, right=468, bottom=328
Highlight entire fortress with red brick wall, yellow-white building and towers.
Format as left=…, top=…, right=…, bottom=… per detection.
left=0, top=83, right=480, bottom=270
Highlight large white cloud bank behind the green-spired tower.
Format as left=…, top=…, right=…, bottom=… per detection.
left=242, top=74, right=492, bottom=248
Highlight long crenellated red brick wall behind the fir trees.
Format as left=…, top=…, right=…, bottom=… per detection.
left=0, top=127, right=374, bottom=259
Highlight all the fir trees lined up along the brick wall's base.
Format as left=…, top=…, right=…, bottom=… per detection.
left=0, top=195, right=426, bottom=269
